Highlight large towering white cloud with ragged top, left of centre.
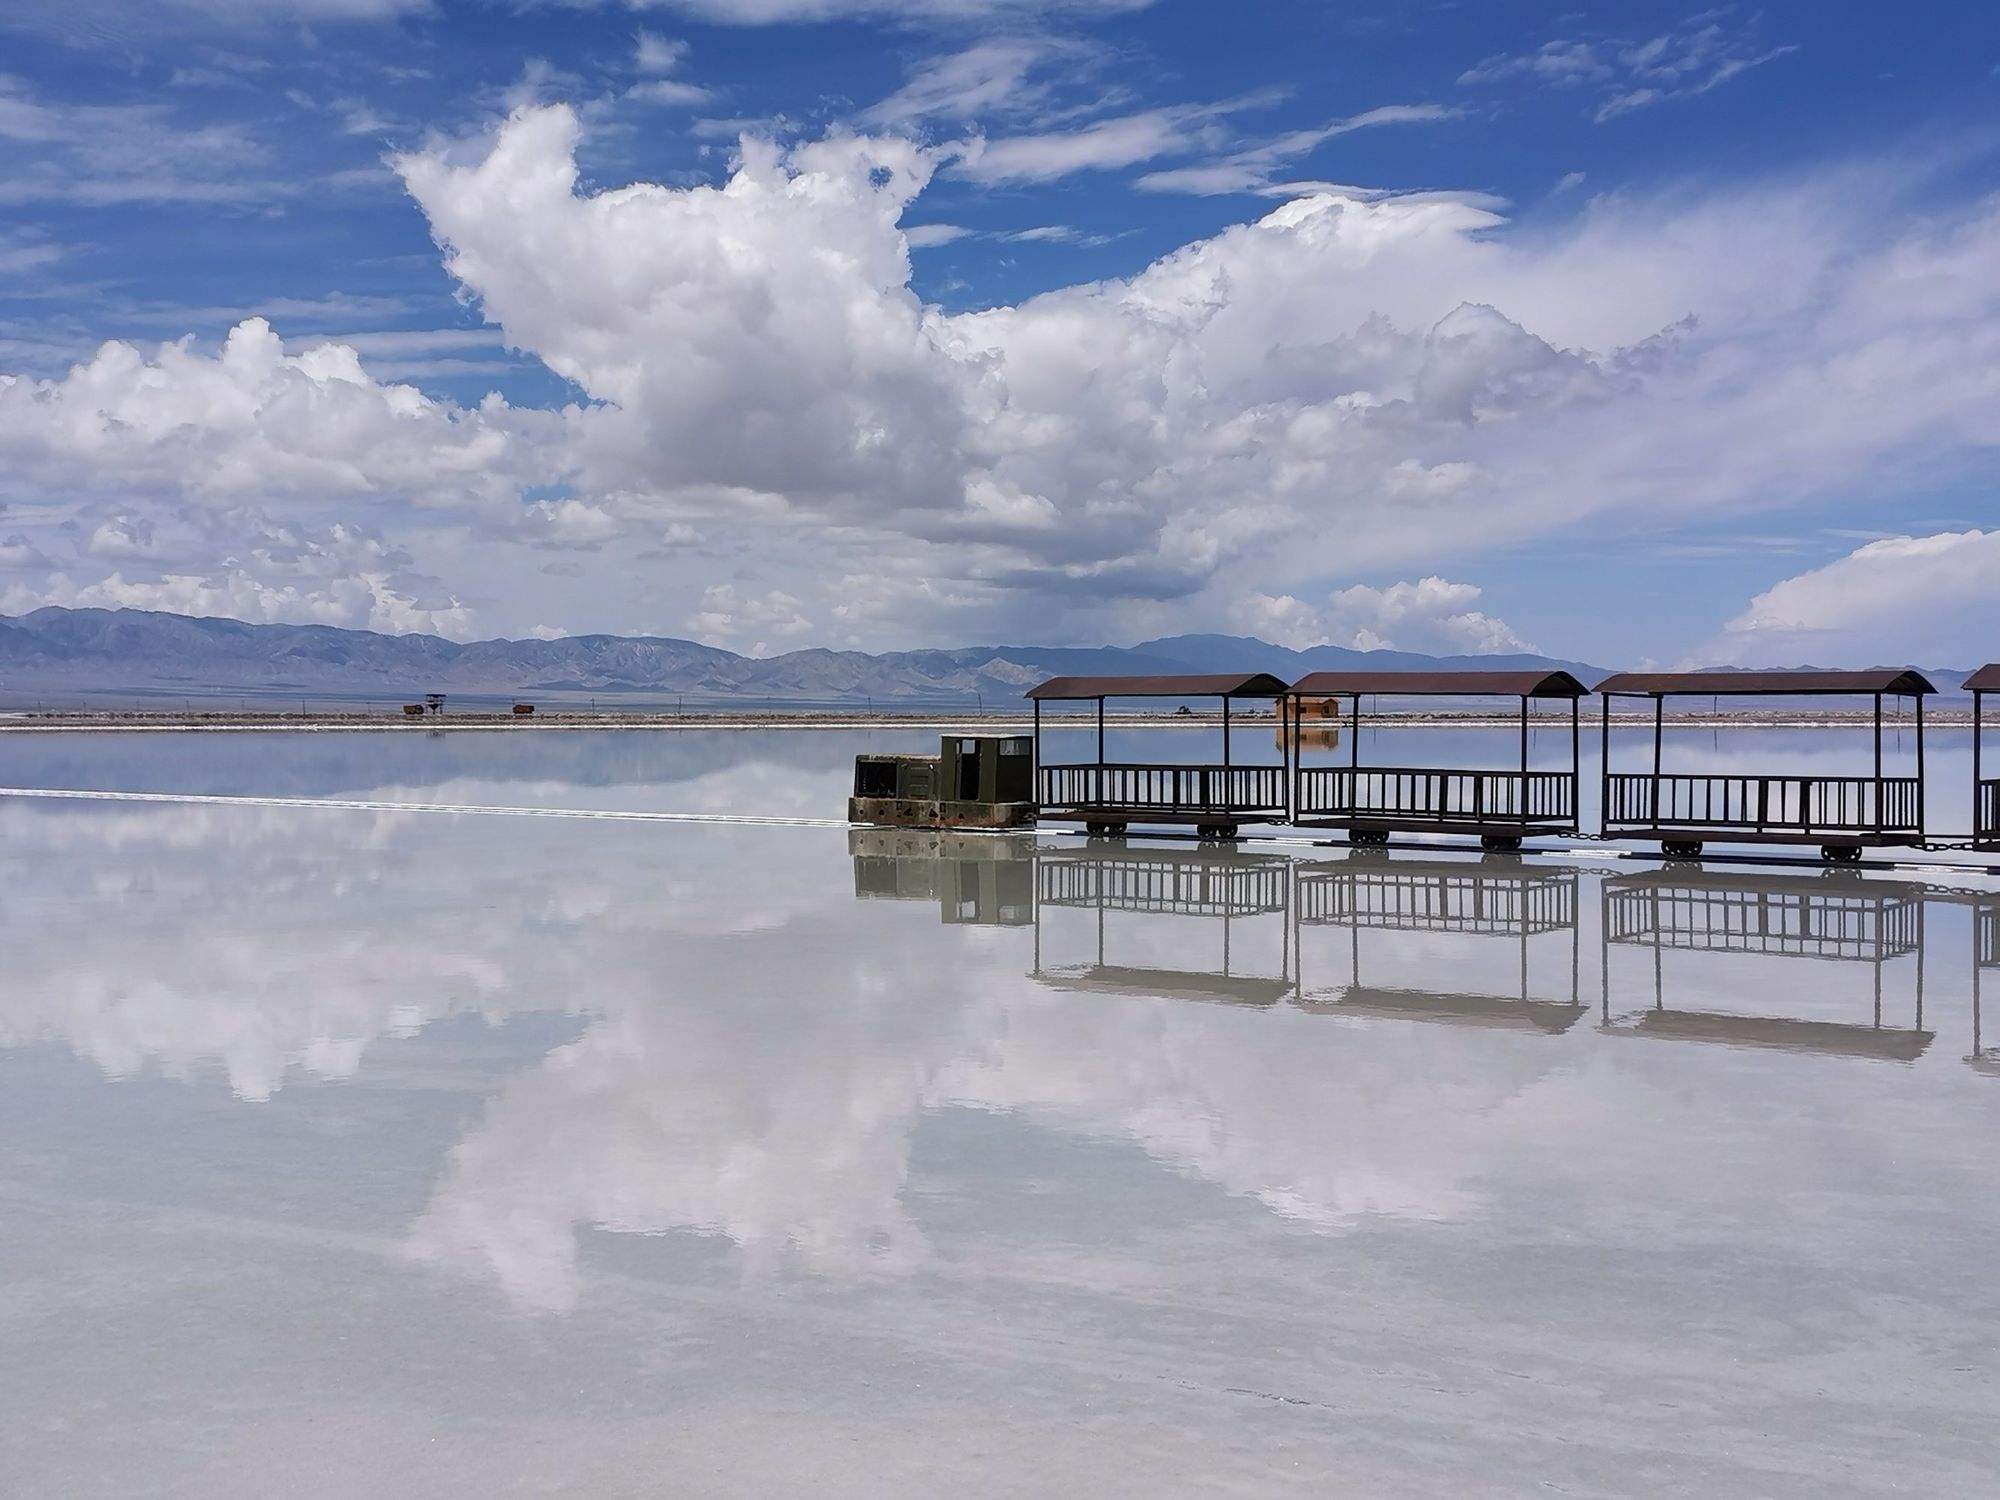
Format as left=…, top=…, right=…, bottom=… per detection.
left=398, top=110, right=970, bottom=520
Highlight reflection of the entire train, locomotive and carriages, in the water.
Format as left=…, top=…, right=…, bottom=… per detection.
left=848, top=828, right=2000, bottom=1074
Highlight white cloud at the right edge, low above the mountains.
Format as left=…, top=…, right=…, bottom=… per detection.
left=1692, top=530, right=2000, bottom=666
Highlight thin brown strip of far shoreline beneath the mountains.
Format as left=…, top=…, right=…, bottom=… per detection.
left=0, top=708, right=1972, bottom=740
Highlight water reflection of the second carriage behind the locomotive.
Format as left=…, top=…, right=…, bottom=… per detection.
left=1294, top=856, right=1584, bottom=1032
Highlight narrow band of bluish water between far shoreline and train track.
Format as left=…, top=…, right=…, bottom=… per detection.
left=0, top=720, right=1972, bottom=830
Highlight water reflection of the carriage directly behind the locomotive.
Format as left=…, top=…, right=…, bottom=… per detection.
left=1032, top=846, right=1292, bottom=1006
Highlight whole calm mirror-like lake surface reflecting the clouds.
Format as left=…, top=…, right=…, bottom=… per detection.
left=0, top=730, right=2000, bottom=1496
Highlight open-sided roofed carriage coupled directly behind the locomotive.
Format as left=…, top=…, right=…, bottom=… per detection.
left=1028, top=672, right=1288, bottom=838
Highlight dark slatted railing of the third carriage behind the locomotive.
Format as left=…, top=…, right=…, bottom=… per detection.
left=1604, top=772, right=1922, bottom=836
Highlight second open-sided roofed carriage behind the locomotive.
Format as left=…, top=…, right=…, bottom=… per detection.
left=1288, top=670, right=1588, bottom=850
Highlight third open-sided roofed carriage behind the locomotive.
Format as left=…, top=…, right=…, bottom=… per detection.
left=1598, top=668, right=1936, bottom=862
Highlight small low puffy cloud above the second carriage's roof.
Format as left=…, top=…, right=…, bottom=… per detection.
left=1236, top=576, right=1534, bottom=656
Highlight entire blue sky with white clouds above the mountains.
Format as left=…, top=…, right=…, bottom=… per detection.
left=0, top=0, right=2000, bottom=666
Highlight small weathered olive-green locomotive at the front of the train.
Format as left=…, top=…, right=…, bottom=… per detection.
left=848, top=734, right=1034, bottom=828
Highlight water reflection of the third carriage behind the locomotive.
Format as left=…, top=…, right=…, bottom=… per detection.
left=1602, top=870, right=1934, bottom=1062
